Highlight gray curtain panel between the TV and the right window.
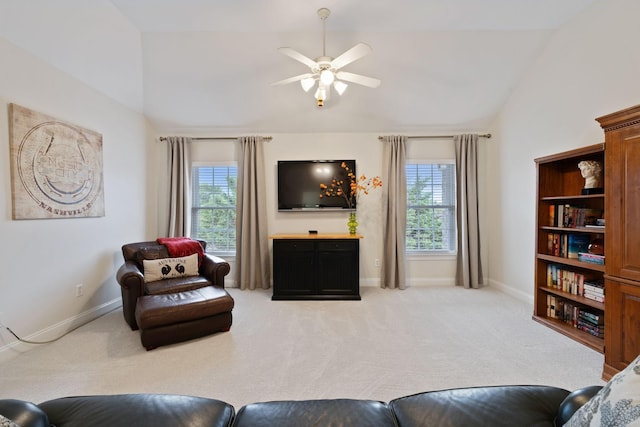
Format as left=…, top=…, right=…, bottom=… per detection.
left=381, top=135, right=407, bottom=289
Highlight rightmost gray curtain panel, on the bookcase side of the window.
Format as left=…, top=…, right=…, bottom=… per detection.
left=453, top=134, right=482, bottom=288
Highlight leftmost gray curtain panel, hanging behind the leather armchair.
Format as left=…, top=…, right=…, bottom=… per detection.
left=167, top=136, right=191, bottom=237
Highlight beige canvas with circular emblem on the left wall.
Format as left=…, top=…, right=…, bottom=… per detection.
left=9, top=104, right=104, bottom=219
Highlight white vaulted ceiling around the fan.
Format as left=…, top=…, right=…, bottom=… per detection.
left=0, top=0, right=595, bottom=133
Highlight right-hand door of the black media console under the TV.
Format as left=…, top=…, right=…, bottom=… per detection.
left=318, top=239, right=360, bottom=295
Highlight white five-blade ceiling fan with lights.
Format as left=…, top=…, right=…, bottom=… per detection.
left=271, top=8, right=380, bottom=107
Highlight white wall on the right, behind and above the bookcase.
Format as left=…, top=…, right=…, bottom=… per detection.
left=486, top=0, right=640, bottom=300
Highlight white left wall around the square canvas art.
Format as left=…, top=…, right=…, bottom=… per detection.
left=0, top=37, right=152, bottom=358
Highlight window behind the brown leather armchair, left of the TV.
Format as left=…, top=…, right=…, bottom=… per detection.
left=191, top=166, right=238, bottom=253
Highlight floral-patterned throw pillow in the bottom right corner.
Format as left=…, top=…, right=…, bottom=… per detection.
left=565, top=356, right=640, bottom=427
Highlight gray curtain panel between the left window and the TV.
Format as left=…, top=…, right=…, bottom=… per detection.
left=236, top=136, right=270, bottom=289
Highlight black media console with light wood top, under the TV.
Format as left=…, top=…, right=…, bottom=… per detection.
left=270, top=234, right=362, bottom=300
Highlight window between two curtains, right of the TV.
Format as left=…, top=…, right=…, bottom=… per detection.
left=406, top=163, right=456, bottom=253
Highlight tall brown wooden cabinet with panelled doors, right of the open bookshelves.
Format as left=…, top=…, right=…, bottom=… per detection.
left=596, top=105, right=640, bottom=379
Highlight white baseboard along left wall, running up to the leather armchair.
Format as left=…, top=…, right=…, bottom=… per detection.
left=0, top=298, right=122, bottom=363
